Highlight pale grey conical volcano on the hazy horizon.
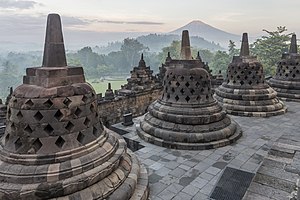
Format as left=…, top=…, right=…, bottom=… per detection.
left=169, top=20, right=241, bottom=48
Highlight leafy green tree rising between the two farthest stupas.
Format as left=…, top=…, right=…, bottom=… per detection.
left=251, top=26, right=292, bottom=75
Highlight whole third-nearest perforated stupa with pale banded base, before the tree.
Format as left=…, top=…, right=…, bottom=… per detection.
left=215, top=33, right=286, bottom=117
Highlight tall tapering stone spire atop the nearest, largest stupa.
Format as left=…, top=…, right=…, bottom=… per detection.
left=43, top=14, right=67, bottom=67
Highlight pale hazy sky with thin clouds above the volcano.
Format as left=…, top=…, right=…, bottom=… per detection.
left=0, top=0, right=300, bottom=47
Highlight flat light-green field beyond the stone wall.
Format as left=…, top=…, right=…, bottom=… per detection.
left=87, top=79, right=127, bottom=96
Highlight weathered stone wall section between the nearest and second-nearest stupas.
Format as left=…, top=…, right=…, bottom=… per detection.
left=98, top=88, right=162, bottom=127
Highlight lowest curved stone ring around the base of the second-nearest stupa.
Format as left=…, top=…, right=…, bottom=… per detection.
left=136, top=120, right=242, bottom=150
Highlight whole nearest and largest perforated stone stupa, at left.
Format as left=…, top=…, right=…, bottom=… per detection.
left=0, top=14, right=148, bottom=200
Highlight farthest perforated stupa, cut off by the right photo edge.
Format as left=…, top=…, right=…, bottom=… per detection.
left=268, top=34, right=300, bottom=102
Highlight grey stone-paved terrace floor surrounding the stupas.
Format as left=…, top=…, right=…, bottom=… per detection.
left=114, top=102, right=300, bottom=200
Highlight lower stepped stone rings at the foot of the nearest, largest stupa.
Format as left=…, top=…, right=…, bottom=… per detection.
left=0, top=129, right=149, bottom=200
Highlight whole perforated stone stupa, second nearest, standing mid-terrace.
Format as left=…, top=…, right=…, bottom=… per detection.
left=137, top=31, right=241, bottom=150
